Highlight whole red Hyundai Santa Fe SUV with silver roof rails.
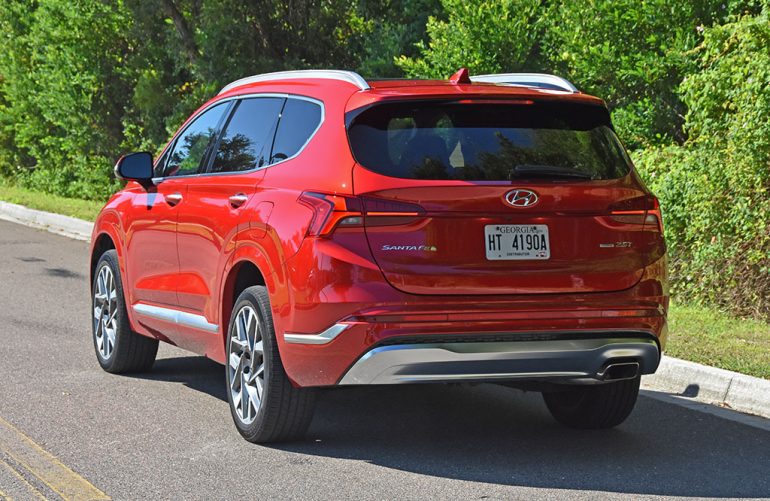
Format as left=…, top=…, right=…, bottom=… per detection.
left=91, top=69, right=668, bottom=442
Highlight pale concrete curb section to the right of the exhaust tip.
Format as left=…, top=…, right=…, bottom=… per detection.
left=642, top=355, right=770, bottom=418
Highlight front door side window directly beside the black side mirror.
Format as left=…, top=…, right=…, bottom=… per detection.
left=165, top=103, right=229, bottom=176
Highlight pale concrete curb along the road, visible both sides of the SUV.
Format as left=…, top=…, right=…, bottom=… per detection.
left=0, top=197, right=770, bottom=418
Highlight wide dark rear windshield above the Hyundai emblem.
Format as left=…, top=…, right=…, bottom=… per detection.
left=348, top=101, right=630, bottom=181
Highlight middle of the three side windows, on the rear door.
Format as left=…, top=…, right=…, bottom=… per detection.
left=211, top=97, right=284, bottom=172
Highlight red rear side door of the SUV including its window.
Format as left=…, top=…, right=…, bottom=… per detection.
left=177, top=96, right=285, bottom=332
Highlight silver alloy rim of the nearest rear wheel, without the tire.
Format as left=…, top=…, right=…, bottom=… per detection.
left=227, top=305, right=265, bottom=424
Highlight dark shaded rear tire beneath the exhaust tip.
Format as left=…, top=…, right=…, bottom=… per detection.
left=543, top=377, right=640, bottom=430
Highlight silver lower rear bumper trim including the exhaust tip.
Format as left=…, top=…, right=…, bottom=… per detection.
left=339, top=333, right=660, bottom=385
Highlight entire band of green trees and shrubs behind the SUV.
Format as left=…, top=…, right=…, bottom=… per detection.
left=0, top=0, right=770, bottom=316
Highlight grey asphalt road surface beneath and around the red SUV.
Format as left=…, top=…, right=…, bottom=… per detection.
left=0, top=221, right=770, bottom=499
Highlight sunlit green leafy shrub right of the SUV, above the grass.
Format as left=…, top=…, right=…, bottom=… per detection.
left=634, top=5, right=770, bottom=318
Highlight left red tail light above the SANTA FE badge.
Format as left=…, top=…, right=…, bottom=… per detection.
left=299, top=191, right=425, bottom=236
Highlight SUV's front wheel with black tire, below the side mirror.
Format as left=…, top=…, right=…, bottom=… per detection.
left=91, top=250, right=158, bottom=374
